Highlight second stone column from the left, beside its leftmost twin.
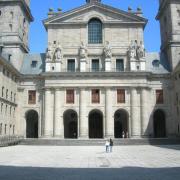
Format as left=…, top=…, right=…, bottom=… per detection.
left=54, top=89, right=64, bottom=138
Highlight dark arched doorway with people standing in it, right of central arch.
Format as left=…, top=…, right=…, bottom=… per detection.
left=114, top=109, right=128, bottom=138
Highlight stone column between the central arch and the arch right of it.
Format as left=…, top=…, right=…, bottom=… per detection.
left=104, top=88, right=114, bottom=138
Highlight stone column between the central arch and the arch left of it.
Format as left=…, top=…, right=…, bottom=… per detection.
left=79, top=88, right=88, bottom=138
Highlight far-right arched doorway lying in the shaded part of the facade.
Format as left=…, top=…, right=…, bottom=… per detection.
left=153, top=109, right=166, bottom=138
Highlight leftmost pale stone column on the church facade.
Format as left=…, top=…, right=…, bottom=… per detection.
left=44, top=89, right=54, bottom=137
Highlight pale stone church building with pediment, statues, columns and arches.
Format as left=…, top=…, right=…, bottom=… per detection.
left=0, top=0, right=180, bottom=139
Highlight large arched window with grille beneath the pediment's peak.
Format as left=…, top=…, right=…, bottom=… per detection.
left=88, top=19, right=102, bottom=44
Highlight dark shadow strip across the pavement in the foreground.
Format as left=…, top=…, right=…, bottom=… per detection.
left=0, top=166, right=180, bottom=180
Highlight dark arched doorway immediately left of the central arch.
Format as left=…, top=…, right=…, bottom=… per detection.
left=63, top=110, right=78, bottom=139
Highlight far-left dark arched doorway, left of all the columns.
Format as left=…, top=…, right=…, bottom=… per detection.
left=26, top=110, right=38, bottom=138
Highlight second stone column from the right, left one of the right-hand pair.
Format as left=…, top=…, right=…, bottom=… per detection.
left=131, top=88, right=141, bottom=138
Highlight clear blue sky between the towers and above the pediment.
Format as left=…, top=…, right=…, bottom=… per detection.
left=29, top=0, right=160, bottom=53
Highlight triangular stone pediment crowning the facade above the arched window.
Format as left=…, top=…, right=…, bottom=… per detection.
left=44, top=3, right=147, bottom=27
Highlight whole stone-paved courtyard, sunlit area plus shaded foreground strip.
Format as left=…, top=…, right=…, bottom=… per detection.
left=0, top=145, right=180, bottom=180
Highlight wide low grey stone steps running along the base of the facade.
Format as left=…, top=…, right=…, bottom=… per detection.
left=20, top=138, right=180, bottom=146
